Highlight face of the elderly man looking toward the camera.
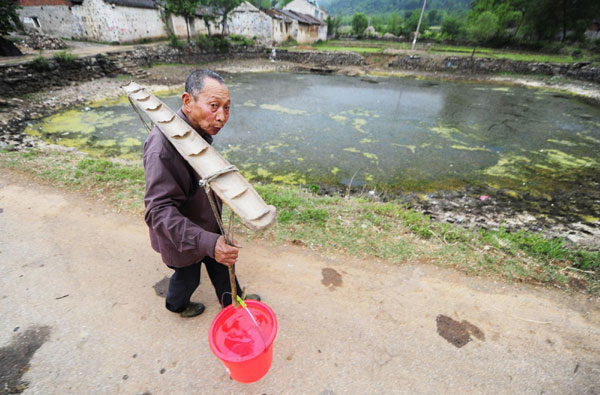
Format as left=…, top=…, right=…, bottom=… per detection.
left=181, top=78, right=231, bottom=136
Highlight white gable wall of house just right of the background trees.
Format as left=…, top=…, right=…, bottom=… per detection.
left=227, top=2, right=273, bottom=45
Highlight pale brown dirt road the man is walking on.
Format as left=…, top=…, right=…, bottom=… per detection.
left=0, top=170, right=600, bottom=394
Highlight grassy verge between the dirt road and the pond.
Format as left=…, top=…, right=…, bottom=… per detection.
left=0, top=150, right=600, bottom=294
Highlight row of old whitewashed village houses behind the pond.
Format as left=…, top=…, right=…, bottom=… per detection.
left=18, top=0, right=327, bottom=46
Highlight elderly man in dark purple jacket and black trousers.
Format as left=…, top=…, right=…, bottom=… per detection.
left=143, top=70, right=260, bottom=317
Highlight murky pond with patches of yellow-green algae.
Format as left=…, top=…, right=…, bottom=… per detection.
left=28, top=73, right=600, bottom=201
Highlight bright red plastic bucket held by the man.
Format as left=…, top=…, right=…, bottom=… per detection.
left=208, top=300, right=277, bottom=383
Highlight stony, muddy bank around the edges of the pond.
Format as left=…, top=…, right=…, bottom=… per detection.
left=0, top=59, right=600, bottom=250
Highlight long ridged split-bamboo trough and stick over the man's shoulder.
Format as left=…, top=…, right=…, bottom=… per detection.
left=122, top=81, right=277, bottom=307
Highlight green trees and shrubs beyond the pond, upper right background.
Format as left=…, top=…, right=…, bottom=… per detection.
left=314, top=0, right=600, bottom=64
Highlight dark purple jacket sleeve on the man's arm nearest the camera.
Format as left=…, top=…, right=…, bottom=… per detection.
left=144, top=151, right=219, bottom=264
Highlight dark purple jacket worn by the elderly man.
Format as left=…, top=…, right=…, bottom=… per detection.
left=143, top=109, right=221, bottom=267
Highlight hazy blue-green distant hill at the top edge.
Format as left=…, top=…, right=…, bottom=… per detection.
left=319, top=0, right=472, bottom=15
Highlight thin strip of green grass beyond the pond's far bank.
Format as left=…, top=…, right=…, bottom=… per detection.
left=291, top=40, right=597, bottom=63
